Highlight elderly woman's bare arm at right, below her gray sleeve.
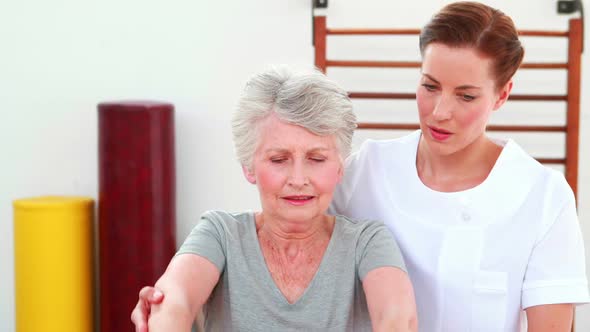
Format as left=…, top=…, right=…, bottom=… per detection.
left=363, top=267, right=418, bottom=332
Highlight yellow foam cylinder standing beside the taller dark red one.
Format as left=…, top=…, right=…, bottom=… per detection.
left=13, top=196, right=94, bottom=332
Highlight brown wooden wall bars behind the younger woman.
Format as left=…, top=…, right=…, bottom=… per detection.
left=313, top=16, right=583, bottom=196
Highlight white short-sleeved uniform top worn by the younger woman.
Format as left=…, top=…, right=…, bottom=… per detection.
left=331, top=131, right=589, bottom=332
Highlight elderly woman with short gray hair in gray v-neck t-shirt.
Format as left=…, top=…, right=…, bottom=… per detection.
left=132, top=68, right=417, bottom=332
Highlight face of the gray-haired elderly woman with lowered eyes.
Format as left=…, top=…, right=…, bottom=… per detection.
left=244, top=115, right=343, bottom=223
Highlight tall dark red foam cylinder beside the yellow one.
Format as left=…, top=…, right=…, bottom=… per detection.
left=98, top=101, right=176, bottom=332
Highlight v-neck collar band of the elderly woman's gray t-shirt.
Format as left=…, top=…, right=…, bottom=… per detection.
left=249, top=212, right=340, bottom=307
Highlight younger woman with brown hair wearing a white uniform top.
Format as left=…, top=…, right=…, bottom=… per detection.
left=332, top=3, right=589, bottom=332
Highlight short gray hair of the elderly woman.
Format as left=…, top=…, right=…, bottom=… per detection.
left=232, top=66, right=356, bottom=169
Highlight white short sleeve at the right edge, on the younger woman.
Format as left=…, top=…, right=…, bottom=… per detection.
left=522, top=195, right=590, bottom=309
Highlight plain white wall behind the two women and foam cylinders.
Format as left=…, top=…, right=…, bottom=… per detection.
left=0, top=0, right=590, bottom=331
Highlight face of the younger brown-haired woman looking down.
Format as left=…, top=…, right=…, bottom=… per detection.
left=416, top=43, right=512, bottom=155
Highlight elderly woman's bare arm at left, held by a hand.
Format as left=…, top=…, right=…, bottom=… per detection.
left=148, top=254, right=220, bottom=332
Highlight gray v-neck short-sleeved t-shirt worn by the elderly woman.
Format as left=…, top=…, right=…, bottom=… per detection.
left=177, top=211, right=406, bottom=331
